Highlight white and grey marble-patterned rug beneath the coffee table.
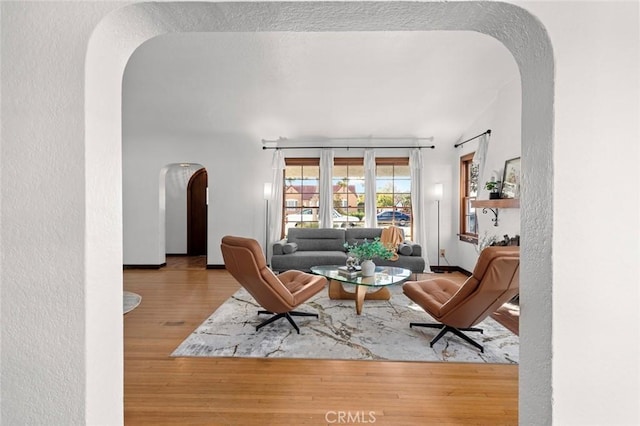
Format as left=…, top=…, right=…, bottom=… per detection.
left=171, top=285, right=519, bottom=364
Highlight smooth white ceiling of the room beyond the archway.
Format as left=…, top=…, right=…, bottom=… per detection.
left=123, top=31, right=519, bottom=143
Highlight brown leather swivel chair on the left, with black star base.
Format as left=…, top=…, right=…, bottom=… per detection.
left=220, top=235, right=327, bottom=334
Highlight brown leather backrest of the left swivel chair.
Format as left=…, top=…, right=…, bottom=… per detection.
left=220, top=236, right=295, bottom=313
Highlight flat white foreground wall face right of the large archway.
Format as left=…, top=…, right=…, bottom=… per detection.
left=535, top=2, right=640, bottom=425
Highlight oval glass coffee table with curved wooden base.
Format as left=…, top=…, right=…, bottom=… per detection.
left=311, top=265, right=411, bottom=315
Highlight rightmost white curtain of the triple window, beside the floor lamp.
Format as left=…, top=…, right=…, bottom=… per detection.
left=409, top=148, right=431, bottom=272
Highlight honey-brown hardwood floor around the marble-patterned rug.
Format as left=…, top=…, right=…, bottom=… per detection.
left=124, top=257, right=518, bottom=426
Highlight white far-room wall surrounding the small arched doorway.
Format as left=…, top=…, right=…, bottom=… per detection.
left=123, top=131, right=271, bottom=265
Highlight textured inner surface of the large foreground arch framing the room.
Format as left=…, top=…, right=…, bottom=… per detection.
left=85, top=2, right=554, bottom=424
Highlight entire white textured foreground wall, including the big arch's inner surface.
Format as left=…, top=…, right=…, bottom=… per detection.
left=0, top=2, right=640, bottom=425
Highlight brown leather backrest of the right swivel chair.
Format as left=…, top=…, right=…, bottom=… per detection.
left=440, top=246, right=520, bottom=328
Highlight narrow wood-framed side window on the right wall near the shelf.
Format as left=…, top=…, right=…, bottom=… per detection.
left=460, top=153, right=478, bottom=244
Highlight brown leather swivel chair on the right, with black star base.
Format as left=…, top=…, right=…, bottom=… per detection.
left=402, top=246, right=520, bottom=352
